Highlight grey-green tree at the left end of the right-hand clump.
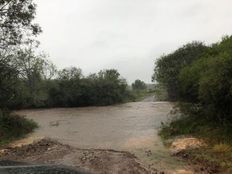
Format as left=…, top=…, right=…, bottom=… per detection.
left=152, top=42, right=208, bottom=100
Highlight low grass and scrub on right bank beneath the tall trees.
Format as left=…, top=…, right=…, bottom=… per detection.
left=159, top=104, right=232, bottom=173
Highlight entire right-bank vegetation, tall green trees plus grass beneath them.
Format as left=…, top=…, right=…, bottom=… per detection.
left=153, top=36, right=232, bottom=172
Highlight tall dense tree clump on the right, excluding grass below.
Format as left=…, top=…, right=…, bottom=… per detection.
left=153, top=36, right=232, bottom=125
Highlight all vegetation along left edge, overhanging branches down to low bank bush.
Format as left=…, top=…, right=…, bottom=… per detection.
left=0, top=0, right=41, bottom=145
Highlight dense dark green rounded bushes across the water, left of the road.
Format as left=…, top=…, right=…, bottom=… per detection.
left=49, top=68, right=128, bottom=107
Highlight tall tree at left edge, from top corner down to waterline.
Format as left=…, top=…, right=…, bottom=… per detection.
left=0, top=0, right=41, bottom=107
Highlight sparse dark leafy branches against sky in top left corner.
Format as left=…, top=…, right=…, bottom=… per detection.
left=0, top=0, right=41, bottom=50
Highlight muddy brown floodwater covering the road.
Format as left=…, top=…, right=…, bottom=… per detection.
left=18, top=100, right=189, bottom=170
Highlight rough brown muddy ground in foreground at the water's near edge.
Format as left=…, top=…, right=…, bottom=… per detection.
left=0, top=139, right=158, bottom=174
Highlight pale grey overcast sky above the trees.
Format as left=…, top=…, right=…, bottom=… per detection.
left=35, top=0, right=232, bottom=83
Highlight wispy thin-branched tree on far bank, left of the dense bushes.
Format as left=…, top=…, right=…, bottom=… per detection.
left=12, top=46, right=56, bottom=106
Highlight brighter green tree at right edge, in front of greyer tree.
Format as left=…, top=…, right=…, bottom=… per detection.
left=179, top=37, right=232, bottom=123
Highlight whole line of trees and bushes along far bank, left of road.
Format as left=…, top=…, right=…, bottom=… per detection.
left=0, top=49, right=132, bottom=109
